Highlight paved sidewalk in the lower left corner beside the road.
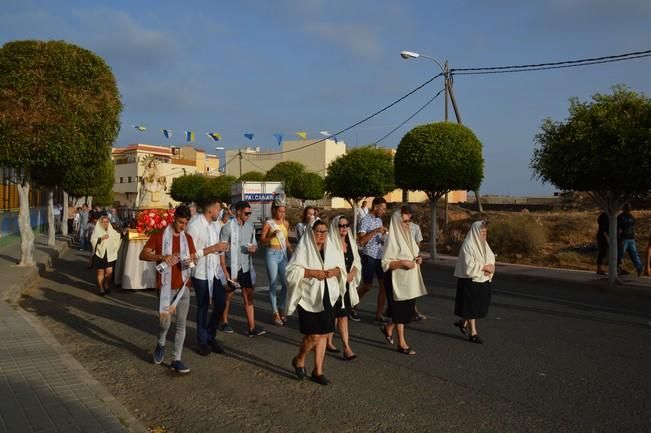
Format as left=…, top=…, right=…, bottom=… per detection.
left=0, top=235, right=146, bottom=433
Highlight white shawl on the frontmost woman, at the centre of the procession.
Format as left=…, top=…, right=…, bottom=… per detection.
left=286, top=223, right=346, bottom=316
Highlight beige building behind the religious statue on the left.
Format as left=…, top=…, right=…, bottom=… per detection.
left=113, top=144, right=220, bottom=208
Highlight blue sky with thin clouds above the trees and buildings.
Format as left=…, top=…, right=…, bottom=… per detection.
left=0, top=0, right=651, bottom=195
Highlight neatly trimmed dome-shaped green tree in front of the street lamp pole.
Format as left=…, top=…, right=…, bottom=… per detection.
left=394, top=122, right=484, bottom=260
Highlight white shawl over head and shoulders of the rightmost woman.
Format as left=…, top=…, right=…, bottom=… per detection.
left=454, top=221, right=495, bottom=283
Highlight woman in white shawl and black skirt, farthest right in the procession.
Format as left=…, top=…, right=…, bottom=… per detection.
left=454, top=221, right=495, bottom=344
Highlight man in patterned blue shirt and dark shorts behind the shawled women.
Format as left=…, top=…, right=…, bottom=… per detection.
left=350, top=197, right=387, bottom=323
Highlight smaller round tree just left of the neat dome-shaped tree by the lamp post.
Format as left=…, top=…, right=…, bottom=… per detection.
left=324, top=146, right=395, bottom=235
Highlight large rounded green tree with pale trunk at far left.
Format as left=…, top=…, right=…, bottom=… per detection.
left=0, top=41, right=122, bottom=265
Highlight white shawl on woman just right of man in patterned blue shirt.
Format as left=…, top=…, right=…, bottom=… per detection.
left=382, top=210, right=427, bottom=301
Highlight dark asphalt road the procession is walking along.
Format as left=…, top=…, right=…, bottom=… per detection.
left=21, top=251, right=651, bottom=433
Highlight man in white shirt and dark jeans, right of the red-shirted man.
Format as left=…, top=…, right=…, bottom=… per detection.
left=187, top=198, right=228, bottom=356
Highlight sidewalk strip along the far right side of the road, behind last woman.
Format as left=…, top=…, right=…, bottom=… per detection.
left=423, top=253, right=651, bottom=296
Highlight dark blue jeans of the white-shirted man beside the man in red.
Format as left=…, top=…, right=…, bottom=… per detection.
left=192, top=277, right=226, bottom=344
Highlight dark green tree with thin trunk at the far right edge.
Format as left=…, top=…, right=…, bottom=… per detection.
left=531, top=85, right=651, bottom=285
